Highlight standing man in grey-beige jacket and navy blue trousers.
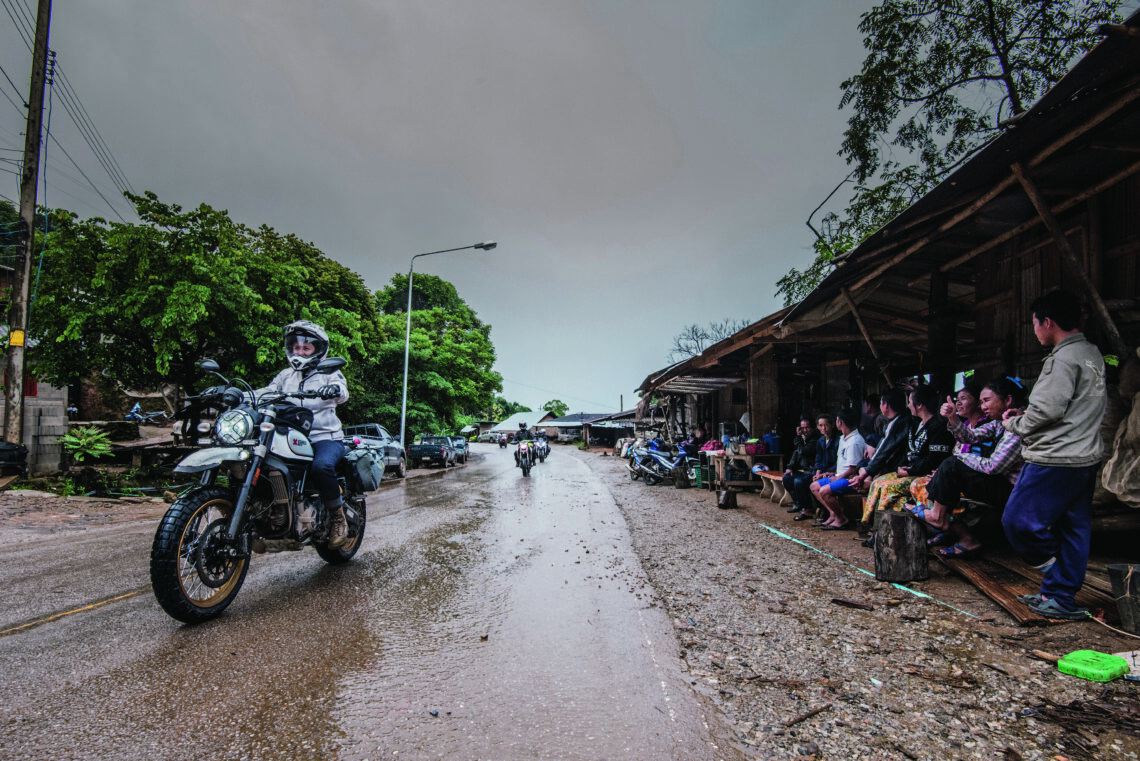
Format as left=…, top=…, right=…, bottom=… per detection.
left=1002, top=291, right=1107, bottom=620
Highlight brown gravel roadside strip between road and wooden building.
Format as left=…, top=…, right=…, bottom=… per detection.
left=576, top=452, right=1140, bottom=759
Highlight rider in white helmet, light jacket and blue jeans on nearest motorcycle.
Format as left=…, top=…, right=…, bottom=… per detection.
left=257, top=320, right=349, bottom=548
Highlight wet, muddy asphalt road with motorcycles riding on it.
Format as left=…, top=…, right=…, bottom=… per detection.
left=0, top=444, right=736, bottom=761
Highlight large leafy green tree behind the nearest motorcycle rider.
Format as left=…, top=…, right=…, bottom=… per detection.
left=30, top=193, right=376, bottom=410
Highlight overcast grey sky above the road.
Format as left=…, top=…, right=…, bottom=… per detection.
left=0, top=0, right=925, bottom=411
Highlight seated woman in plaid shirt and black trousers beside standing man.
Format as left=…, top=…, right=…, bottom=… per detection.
left=906, top=378, right=1024, bottom=557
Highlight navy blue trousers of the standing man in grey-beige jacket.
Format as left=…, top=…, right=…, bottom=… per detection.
left=1002, top=463, right=1100, bottom=608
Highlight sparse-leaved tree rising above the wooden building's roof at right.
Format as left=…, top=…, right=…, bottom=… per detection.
left=776, top=0, right=1121, bottom=305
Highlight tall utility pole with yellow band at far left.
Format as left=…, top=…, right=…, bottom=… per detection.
left=3, top=0, right=51, bottom=444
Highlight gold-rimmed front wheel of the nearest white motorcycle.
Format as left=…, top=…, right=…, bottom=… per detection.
left=150, top=486, right=250, bottom=623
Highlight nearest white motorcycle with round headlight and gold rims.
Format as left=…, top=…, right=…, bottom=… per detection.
left=150, top=357, right=369, bottom=623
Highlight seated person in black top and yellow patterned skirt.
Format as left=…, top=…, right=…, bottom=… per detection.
left=860, top=386, right=954, bottom=530
